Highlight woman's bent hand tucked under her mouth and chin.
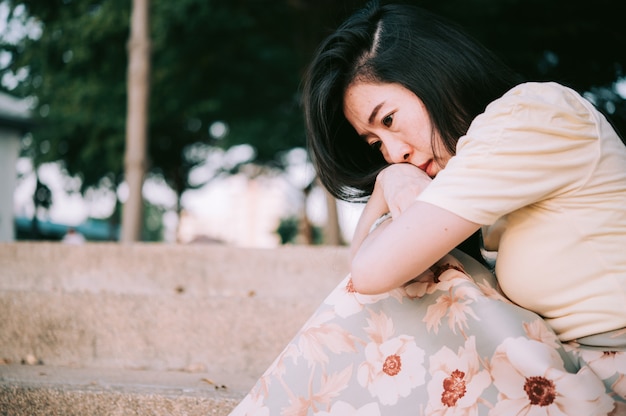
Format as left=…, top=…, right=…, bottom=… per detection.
left=374, top=163, right=432, bottom=218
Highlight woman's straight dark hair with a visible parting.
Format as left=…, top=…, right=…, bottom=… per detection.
left=303, top=3, right=521, bottom=200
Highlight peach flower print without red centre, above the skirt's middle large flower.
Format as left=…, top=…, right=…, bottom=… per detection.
left=422, top=285, right=480, bottom=334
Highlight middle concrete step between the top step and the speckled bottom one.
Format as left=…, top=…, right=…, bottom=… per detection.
left=0, top=292, right=319, bottom=384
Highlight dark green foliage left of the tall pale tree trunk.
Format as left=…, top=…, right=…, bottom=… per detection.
left=5, top=0, right=129, bottom=191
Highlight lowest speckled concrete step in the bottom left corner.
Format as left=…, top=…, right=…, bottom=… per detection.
left=0, top=365, right=245, bottom=416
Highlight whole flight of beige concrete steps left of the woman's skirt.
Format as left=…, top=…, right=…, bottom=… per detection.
left=0, top=243, right=347, bottom=416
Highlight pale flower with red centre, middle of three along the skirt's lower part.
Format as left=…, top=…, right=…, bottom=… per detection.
left=426, top=337, right=491, bottom=416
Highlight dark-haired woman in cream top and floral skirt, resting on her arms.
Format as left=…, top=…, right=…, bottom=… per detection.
left=228, top=1, right=626, bottom=416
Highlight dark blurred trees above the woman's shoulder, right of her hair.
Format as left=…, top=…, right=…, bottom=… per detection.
left=424, top=0, right=626, bottom=139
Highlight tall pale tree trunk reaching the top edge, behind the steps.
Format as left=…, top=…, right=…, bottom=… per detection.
left=121, top=0, right=150, bottom=242
